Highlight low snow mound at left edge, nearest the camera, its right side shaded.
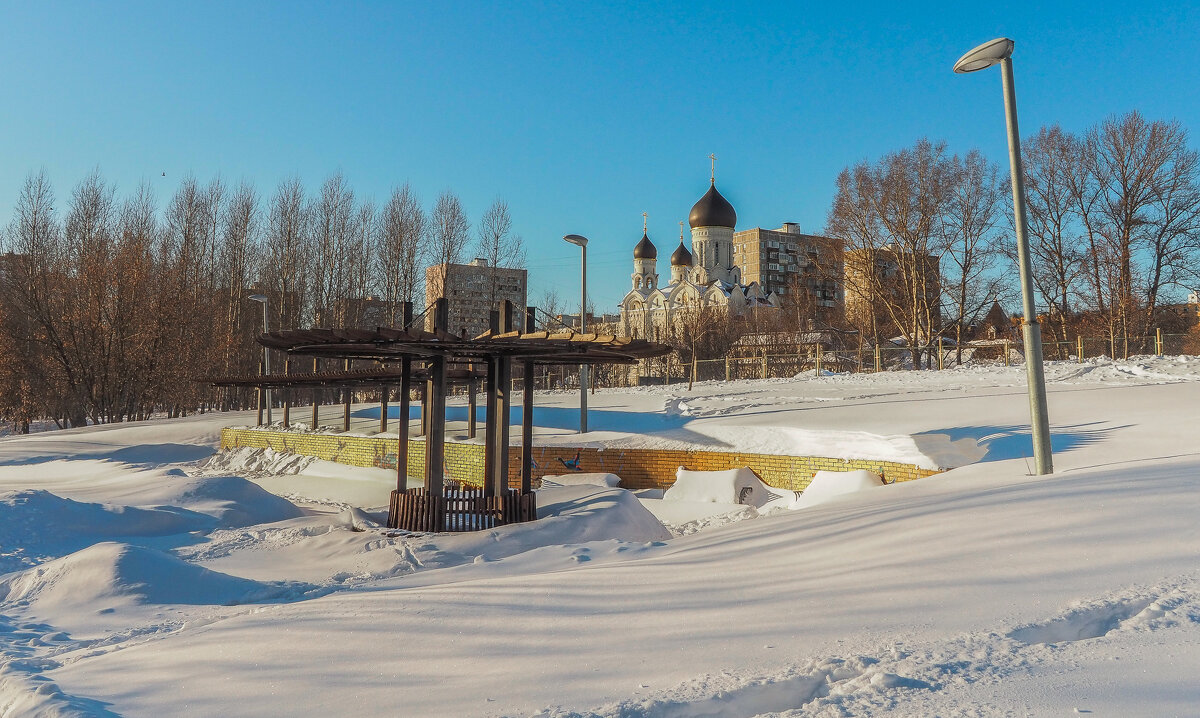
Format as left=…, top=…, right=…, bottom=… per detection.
left=0, top=542, right=295, bottom=623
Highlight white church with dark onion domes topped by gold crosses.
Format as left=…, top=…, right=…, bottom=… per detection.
left=620, top=176, right=779, bottom=340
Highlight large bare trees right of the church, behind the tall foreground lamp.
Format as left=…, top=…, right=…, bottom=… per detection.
left=824, top=112, right=1200, bottom=366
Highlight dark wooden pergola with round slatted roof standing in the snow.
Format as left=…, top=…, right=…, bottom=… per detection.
left=210, top=299, right=672, bottom=531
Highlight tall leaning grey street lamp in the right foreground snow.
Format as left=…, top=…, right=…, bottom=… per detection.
left=954, top=37, right=1054, bottom=475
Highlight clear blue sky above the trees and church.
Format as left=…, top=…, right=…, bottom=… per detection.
left=0, top=1, right=1200, bottom=311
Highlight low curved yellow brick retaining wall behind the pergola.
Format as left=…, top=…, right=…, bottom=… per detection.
left=221, top=429, right=938, bottom=491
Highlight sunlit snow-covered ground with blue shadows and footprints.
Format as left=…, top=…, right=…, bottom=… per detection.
left=0, top=358, right=1200, bottom=718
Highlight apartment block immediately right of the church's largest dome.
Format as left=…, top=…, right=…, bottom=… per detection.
left=733, top=222, right=844, bottom=321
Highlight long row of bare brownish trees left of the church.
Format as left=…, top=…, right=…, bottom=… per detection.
left=0, top=170, right=524, bottom=431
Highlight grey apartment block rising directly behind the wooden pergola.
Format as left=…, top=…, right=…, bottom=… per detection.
left=425, top=258, right=529, bottom=337
